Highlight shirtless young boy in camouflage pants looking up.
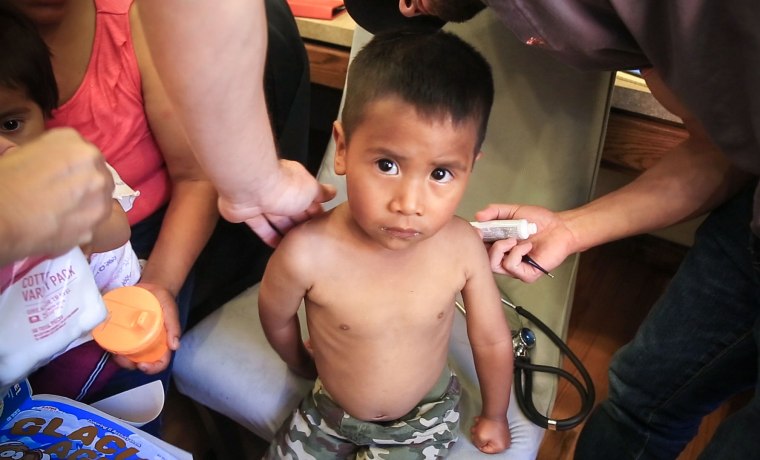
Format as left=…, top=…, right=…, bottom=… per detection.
left=259, top=31, right=512, bottom=459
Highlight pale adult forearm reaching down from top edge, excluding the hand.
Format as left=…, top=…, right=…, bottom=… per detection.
left=139, top=0, right=279, bottom=202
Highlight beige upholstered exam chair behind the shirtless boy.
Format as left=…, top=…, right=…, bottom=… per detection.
left=174, top=11, right=613, bottom=459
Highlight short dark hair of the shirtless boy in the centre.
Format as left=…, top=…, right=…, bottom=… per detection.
left=341, top=30, right=494, bottom=151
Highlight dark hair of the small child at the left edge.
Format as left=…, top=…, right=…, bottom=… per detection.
left=0, top=1, right=58, bottom=117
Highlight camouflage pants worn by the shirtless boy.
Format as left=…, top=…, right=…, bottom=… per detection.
left=264, top=369, right=461, bottom=460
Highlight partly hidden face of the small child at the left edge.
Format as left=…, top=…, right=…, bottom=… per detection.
left=0, top=87, right=45, bottom=150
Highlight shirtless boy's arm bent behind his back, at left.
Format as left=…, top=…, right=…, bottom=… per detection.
left=259, top=239, right=317, bottom=379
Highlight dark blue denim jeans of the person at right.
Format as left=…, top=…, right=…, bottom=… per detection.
left=575, top=186, right=760, bottom=460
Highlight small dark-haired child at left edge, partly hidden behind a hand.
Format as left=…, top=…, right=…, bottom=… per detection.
left=0, top=2, right=140, bottom=402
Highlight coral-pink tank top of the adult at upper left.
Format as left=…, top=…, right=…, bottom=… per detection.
left=47, top=0, right=171, bottom=225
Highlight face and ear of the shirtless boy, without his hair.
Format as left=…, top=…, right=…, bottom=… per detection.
left=333, top=97, right=477, bottom=249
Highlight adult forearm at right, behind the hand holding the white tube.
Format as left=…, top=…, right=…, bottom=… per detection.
left=559, top=136, right=749, bottom=253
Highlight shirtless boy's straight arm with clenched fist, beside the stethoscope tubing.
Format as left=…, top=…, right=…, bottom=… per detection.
left=462, top=230, right=514, bottom=454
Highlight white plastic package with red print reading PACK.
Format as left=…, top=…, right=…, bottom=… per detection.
left=0, top=248, right=106, bottom=393
